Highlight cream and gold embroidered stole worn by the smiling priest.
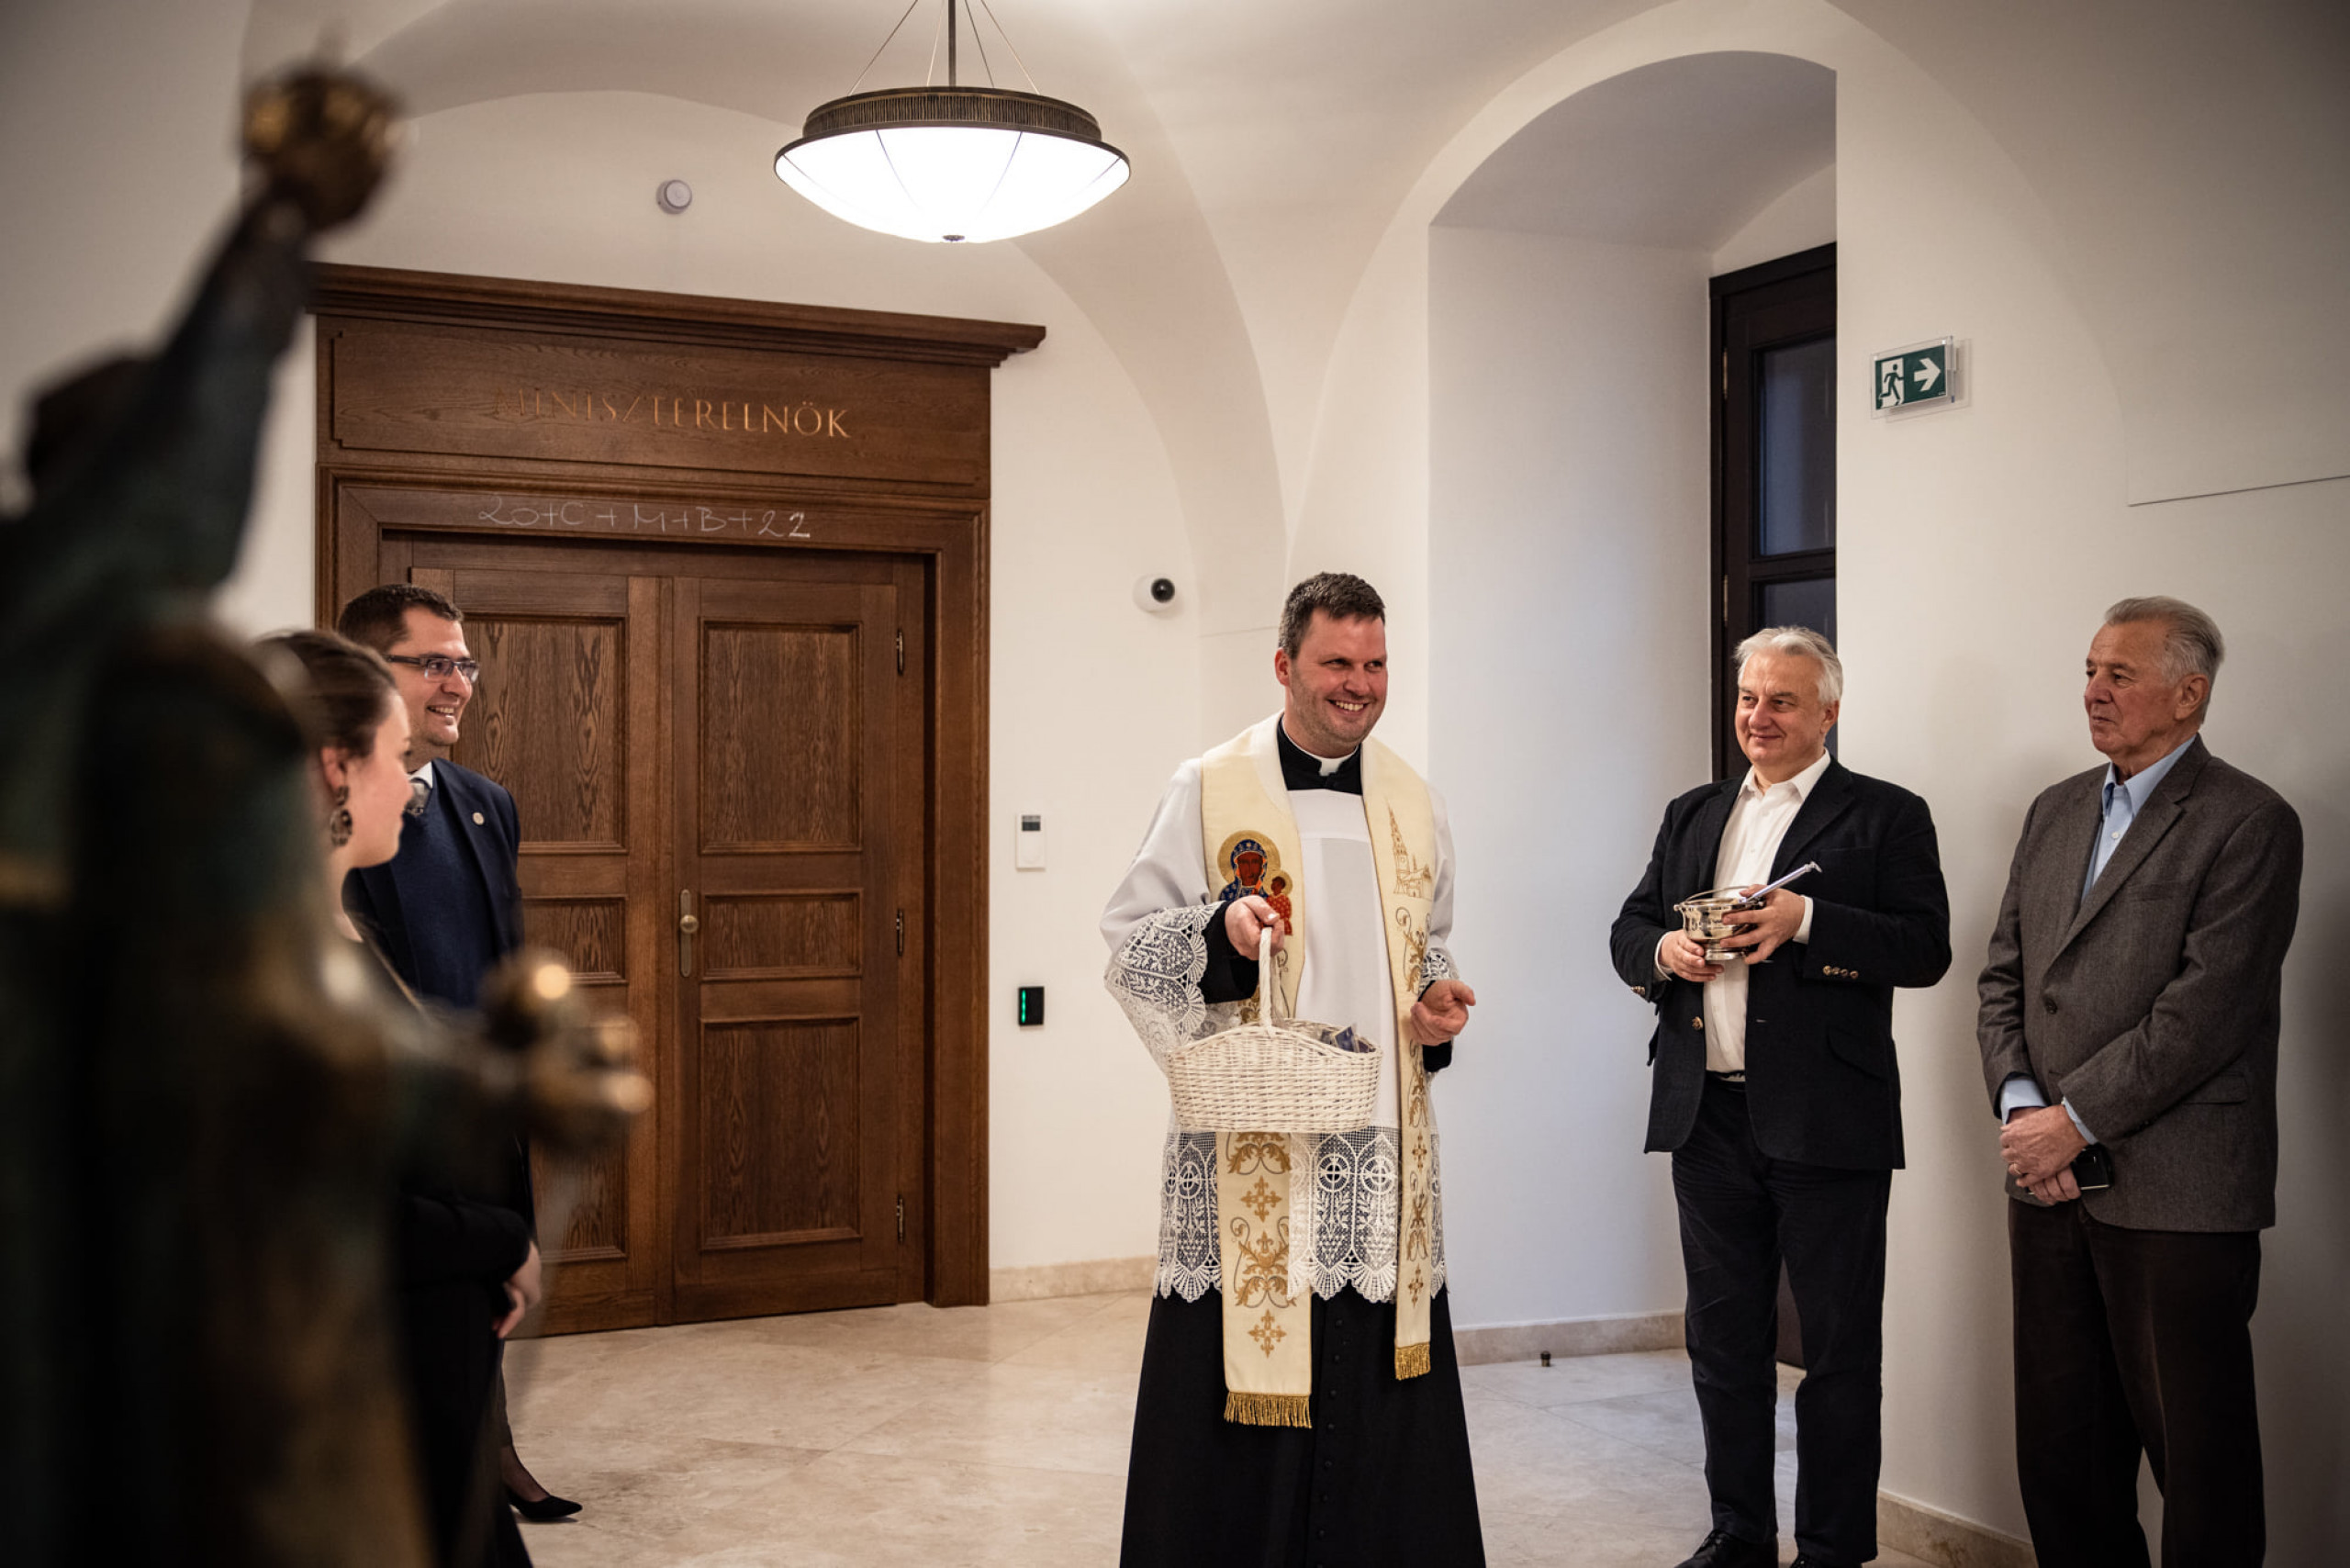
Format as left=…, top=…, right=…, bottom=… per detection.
left=1201, top=714, right=1436, bottom=1427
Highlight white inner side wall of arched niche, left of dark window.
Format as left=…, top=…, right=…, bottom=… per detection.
left=1428, top=228, right=1708, bottom=1326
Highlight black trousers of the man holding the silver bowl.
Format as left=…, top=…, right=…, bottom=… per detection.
left=1673, top=1077, right=1892, bottom=1563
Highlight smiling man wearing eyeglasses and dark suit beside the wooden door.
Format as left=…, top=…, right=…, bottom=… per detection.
left=336, top=583, right=578, bottom=1518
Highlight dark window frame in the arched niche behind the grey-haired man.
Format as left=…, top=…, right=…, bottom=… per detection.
left=1707, top=242, right=1835, bottom=778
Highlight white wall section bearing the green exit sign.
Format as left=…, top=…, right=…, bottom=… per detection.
left=1838, top=39, right=2350, bottom=1563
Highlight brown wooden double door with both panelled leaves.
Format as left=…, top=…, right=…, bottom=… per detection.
left=383, top=536, right=928, bottom=1330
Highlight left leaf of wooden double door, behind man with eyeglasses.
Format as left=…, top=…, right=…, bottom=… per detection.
left=411, top=556, right=665, bottom=1330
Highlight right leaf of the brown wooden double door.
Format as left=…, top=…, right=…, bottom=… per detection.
left=670, top=578, right=912, bottom=1316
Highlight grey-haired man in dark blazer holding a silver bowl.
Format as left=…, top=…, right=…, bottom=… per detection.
left=1610, top=628, right=1951, bottom=1568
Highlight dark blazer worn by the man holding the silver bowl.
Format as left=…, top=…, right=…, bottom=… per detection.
left=1610, top=762, right=1951, bottom=1170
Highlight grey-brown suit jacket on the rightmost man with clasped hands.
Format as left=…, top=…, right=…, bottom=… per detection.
left=1976, top=738, right=2300, bottom=1232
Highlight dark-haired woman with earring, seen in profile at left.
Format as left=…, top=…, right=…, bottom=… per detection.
left=259, top=633, right=541, bottom=1568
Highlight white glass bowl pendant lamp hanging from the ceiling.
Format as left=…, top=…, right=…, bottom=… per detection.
left=776, top=0, right=1128, bottom=242
